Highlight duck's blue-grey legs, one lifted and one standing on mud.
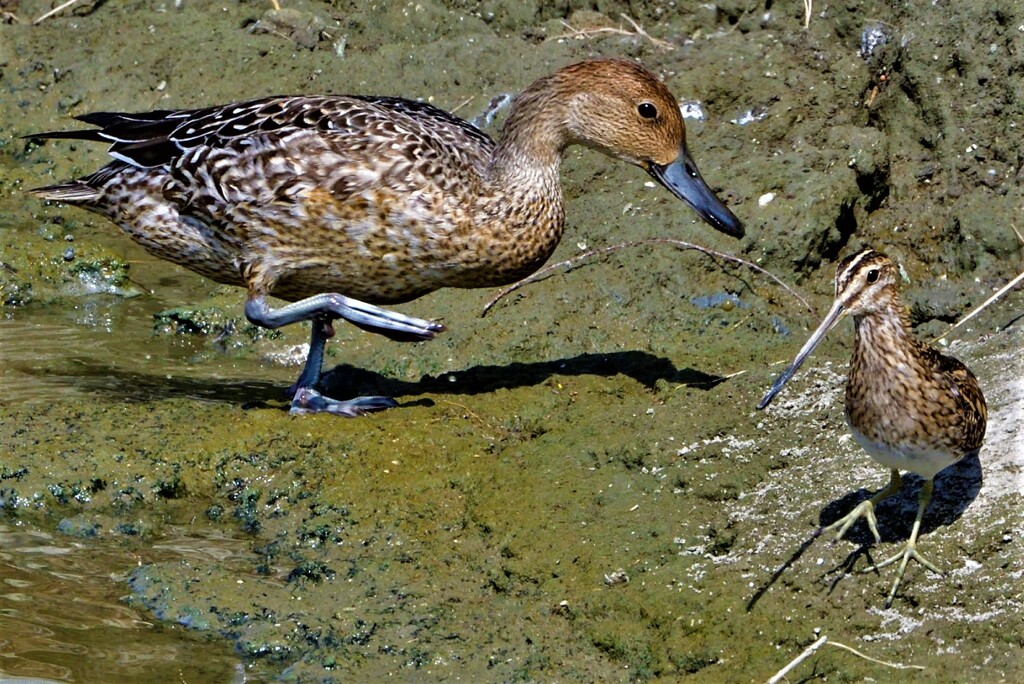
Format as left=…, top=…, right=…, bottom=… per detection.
left=246, top=293, right=444, bottom=418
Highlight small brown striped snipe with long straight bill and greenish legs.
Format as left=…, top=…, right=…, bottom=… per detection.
left=758, top=250, right=988, bottom=608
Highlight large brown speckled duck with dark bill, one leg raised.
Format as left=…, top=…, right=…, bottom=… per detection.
left=31, top=59, right=743, bottom=416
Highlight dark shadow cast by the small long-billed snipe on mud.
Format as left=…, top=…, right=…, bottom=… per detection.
left=746, top=454, right=983, bottom=611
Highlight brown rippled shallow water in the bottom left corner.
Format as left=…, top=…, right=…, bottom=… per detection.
left=0, top=522, right=264, bottom=684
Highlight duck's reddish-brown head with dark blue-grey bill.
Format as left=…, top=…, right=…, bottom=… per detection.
left=553, top=59, right=743, bottom=238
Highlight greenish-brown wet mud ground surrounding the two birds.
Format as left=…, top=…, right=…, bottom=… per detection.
left=0, top=0, right=1024, bottom=682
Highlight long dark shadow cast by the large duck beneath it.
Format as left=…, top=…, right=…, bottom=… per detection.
left=24, top=351, right=727, bottom=411
